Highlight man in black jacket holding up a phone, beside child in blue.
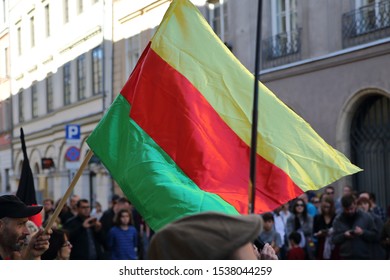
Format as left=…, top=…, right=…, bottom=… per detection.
left=64, top=199, right=103, bottom=260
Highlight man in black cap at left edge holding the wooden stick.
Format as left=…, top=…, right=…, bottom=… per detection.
left=0, top=195, right=51, bottom=260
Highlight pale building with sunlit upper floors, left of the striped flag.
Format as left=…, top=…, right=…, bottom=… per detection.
left=2, top=0, right=112, bottom=209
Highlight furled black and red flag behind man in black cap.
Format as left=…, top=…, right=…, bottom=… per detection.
left=16, top=128, right=42, bottom=227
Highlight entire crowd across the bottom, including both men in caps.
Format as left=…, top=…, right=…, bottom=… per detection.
left=0, top=186, right=390, bottom=260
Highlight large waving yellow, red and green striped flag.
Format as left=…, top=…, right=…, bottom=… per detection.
left=87, top=0, right=360, bottom=230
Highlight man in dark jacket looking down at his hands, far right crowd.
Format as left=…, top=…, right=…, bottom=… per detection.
left=332, top=194, right=377, bottom=260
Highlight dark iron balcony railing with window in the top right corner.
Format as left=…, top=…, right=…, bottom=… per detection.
left=342, top=0, right=390, bottom=48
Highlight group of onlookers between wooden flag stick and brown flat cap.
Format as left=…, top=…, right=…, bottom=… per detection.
left=42, top=192, right=151, bottom=260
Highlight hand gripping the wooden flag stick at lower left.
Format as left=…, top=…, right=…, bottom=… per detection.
left=21, top=228, right=52, bottom=260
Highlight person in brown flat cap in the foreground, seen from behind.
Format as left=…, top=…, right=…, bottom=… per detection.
left=148, top=212, right=278, bottom=260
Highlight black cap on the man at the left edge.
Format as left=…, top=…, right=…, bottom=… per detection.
left=0, top=195, right=43, bottom=219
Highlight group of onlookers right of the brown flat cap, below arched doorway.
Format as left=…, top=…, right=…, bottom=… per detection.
left=260, top=186, right=390, bottom=260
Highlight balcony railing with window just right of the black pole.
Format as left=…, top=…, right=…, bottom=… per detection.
left=262, top=28, right=301, bottom=69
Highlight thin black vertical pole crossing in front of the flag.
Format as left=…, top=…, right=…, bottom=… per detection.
left=248, top=0, right=263, bottom=214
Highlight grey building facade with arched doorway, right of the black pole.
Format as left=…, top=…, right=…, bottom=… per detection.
left=261, top=0, right=390, bottom=207
